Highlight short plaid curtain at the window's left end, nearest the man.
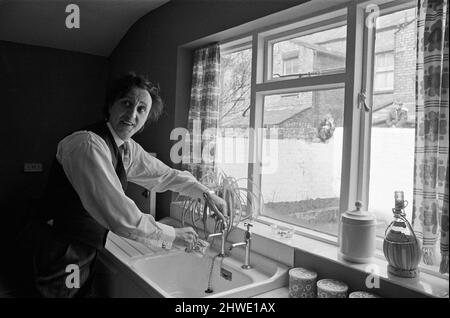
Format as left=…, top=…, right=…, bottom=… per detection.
left=183, top=44, right=220, bottom=180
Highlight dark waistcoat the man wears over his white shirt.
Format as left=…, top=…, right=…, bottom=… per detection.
left=39, top=122, right=127, bottom=249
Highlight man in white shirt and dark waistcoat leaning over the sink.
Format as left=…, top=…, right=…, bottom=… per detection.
left=30, top=74, right=226, bottom=297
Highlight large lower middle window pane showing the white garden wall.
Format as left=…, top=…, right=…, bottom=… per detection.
left=261, top=88, right=344, bottom=235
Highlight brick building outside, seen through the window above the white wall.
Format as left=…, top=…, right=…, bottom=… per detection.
left=221, top=10, right=416, bottom=141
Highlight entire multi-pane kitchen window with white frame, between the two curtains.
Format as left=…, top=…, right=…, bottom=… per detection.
left=209, top=1, right=442, bottom=278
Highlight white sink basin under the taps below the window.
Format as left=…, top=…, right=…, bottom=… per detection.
left=130, top=249, right=289, bottom=298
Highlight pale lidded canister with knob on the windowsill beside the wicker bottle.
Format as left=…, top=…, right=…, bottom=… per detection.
left=340, top=201, right=376, bottom=263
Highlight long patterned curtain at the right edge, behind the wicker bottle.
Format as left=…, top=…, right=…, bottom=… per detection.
left=412, top=0, right=449, bottom=273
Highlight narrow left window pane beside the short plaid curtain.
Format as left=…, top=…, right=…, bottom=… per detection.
left=216, top=49, right=252, bottom=187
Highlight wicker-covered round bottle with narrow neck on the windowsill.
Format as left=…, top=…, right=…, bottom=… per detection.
left=383, top=191, right=422, bottom=278
